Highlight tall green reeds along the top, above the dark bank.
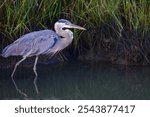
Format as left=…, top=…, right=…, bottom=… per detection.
left=0, top=0, right=150, bottom=49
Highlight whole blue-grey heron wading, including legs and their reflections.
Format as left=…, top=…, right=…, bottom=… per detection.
left=2, top=19, right=86, bottom=97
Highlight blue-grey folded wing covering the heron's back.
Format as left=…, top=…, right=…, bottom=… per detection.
left=2, top=30, right=59, bottom=57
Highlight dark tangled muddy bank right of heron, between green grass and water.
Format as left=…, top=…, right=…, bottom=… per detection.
left=78, top=26, right=150, bottom=65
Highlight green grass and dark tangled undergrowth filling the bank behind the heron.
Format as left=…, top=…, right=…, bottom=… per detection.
left=0, top=0, right=150, bottom=62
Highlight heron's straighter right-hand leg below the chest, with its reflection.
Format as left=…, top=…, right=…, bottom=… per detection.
left=33, top=56, right=39, bottom=95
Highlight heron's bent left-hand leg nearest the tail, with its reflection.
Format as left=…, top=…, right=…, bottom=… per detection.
left=11, top=57, right=28, bottom=97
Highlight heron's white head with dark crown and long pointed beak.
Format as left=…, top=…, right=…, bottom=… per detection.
left=55, top=19, right=86, bottom=30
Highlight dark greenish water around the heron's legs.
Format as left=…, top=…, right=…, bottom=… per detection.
left=0, top=62, right=150, bottom=99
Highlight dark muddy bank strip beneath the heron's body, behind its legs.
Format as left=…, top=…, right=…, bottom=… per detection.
left=0, top=49, right=76, bottom=69
